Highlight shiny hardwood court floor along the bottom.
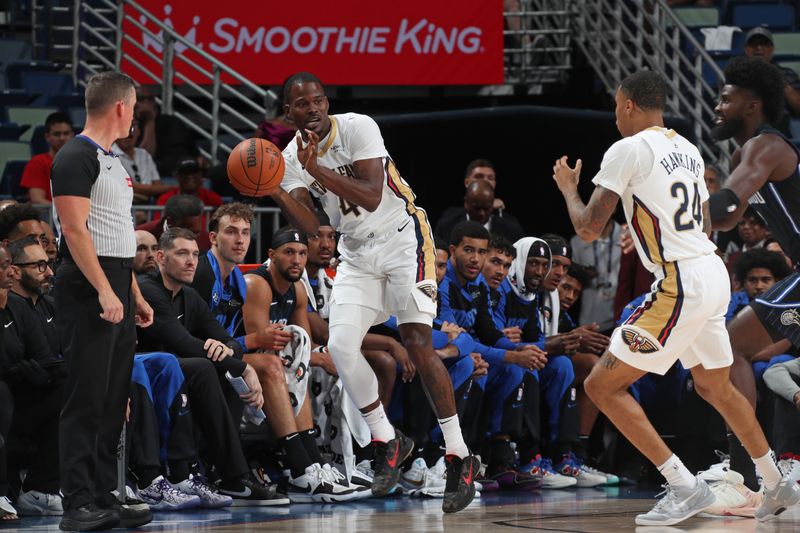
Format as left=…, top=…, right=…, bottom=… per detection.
left=6, top=487, right=800, bottom=533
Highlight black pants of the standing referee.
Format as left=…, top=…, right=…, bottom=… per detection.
left=55, top=258, right=136, bottom=511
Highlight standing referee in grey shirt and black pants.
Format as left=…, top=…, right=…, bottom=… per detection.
left=50, top=72, right=153, bottom=531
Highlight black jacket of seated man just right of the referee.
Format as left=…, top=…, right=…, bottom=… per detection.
left=136, top=270, right=245, bottom=376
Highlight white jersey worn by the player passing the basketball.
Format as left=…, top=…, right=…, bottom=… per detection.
left=281, top=113, right=417, bottom=239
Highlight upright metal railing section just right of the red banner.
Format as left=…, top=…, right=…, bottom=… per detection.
left=503, top=0, right=578, bottom=86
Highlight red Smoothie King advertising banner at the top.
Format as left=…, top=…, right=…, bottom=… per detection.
left=123, top=0, right=503, bottom=85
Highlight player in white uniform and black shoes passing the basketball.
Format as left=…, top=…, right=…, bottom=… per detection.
left=272, top=72, right=480, bottom=512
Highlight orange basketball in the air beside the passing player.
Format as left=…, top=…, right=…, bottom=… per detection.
left=227, top=138, right=286, bottom=197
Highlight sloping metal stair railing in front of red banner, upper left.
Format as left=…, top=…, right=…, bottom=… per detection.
left=72, top=0, right=277, bottom=163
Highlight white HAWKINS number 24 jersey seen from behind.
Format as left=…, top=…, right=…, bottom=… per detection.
left=592, top=127, right=716, bottom=272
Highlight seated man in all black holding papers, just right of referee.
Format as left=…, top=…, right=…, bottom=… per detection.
left=137, top=228, right=288, bottom=505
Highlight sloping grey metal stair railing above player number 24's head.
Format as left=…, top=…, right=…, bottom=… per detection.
left=575, top=0, right=733, bottom=168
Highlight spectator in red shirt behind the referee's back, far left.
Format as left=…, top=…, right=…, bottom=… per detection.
left=20, top=112, right=75, bottom=204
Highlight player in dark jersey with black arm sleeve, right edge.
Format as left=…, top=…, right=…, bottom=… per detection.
left=709, top=57, right=800, bottom=512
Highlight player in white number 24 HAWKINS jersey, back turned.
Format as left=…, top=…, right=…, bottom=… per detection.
left=553, top=71, right=798, bottom=526
